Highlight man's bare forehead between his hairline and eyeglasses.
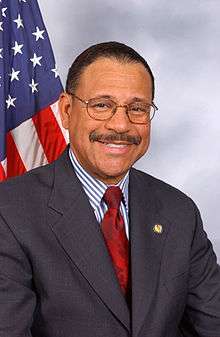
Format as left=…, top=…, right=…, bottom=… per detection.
left=74, top=57, right=152, bottom=100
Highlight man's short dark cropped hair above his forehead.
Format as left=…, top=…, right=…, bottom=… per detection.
left=65, top=41, right=154, bottom=98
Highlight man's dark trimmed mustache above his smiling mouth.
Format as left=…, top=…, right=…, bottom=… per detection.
left=89, top=131, right=141, bottom=145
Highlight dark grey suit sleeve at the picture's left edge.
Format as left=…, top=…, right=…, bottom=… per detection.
left=0, top=215, right=36, bottom=337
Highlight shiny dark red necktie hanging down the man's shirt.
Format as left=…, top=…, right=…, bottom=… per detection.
left=101, top=186, right=129, bottom=295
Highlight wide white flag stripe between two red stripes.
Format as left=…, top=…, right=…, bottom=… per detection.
left=11, top=118, right=48, bottom=171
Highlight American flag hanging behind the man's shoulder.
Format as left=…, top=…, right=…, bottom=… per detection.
left=0, top=0, right=67, bottom=181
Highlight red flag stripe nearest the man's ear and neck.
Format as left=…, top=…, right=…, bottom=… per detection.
left=32, top=106, right=66, bottom=163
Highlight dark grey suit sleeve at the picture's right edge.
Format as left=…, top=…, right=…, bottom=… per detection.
left=182, top=204, right=220, bottom=337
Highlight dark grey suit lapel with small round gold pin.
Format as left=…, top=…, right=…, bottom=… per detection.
left=129, top=170, right=169, bottom=337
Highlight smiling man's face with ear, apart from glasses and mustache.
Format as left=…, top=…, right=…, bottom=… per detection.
left=60, top=58, right=152, bottom=184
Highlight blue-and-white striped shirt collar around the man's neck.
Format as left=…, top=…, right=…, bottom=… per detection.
left=69, top=148, right=129, bottom=212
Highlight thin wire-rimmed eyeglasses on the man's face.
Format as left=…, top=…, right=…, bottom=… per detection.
left=70, top=93, right=158, bottom=124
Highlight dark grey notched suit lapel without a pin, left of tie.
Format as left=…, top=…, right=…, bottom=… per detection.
left=45, top=151, right=130, bottom=330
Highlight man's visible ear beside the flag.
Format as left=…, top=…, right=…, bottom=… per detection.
left=58, top=92, right=72, bottom=129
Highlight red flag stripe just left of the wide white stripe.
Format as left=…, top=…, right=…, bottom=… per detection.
left=6, top=132, right=26, bottom=178
